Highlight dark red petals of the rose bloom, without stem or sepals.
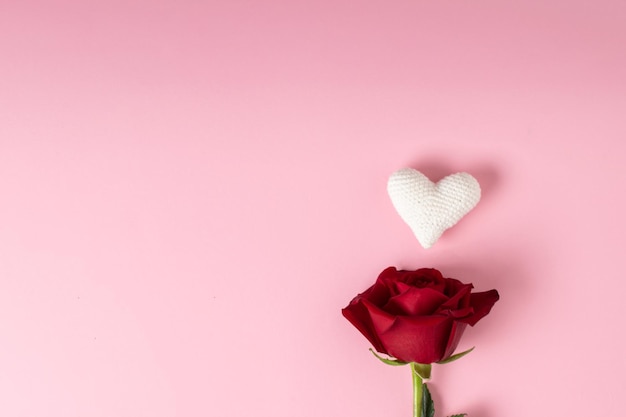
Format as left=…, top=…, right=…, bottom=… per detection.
left=342, top=267, right=500, bottom=364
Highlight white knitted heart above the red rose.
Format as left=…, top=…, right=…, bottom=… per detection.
left=387, top=168, right=480, bottom=249
